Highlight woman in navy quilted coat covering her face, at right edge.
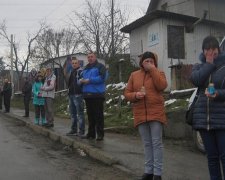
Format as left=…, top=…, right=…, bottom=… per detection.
left=191, top=36, right=225, bottom=180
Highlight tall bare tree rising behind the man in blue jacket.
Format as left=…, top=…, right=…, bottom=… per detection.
left=70, top=0, right=128, bottom=59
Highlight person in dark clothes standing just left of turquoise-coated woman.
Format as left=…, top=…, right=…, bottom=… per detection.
left=22, top=77, right=32, bottom=117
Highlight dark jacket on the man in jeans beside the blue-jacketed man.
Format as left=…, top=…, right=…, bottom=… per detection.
left=68, top=68, right=82, bottom=95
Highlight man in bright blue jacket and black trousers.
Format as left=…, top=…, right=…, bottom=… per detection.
left=80, top=52, right=107, bottom=141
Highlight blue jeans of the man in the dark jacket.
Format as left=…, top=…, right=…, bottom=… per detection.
left=69, top=95, right=85, bottom=135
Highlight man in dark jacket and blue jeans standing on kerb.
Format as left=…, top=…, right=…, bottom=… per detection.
left=67, top=57, right=85, bottom=136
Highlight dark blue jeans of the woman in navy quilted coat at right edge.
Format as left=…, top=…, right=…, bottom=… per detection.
left=199, top=130, right=225, bottom=180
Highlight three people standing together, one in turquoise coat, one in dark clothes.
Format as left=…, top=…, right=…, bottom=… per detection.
left=22, top=66, right=56, bottom=127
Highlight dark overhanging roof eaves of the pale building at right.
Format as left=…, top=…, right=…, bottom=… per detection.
left=120, top=9, right=225, bottom=33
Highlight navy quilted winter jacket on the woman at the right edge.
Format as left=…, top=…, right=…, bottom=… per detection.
left=191, top=54, right=225, bottom=130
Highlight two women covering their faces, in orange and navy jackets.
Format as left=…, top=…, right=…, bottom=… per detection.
left=124, top=36, right=225, bottom=180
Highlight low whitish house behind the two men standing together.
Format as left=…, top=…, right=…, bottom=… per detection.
left=40, top=52, right=105, bottom=91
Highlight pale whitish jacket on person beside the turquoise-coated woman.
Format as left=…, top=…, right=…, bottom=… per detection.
left=42, top=73, right=56, bottom=98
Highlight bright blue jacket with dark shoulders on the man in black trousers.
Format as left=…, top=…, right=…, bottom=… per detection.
left=82, top=61, right=107, bottom=98
